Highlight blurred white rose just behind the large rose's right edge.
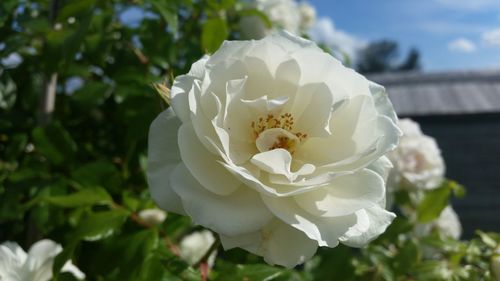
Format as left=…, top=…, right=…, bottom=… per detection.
left=389, top=119, right=445, bottom=189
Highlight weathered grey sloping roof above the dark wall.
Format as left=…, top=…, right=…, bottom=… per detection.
left=368, top=70, right=500, bottom=116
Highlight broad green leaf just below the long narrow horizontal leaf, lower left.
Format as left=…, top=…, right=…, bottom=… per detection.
left=75, top=209, right=129, bottom=241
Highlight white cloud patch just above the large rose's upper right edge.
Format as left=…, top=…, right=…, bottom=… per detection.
left=309, top=17, right=367, bottom=61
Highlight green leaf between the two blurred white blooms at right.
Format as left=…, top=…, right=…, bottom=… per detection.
left=417, top=184, right=451, bottom=223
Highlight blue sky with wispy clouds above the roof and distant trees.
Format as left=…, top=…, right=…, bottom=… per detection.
left=309, top=0, right=500, bottom=71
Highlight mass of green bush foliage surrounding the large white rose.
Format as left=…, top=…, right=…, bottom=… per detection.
left=0, top=0, right=500, bottom=281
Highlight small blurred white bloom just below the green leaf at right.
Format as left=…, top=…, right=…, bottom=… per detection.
left=416, top=206, right=462, bottom=239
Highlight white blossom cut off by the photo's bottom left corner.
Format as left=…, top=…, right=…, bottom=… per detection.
left=0, top=239, right=85, bottom=281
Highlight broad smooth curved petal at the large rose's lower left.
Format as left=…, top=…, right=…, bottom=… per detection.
left=170, top=164, right=273, bottom=236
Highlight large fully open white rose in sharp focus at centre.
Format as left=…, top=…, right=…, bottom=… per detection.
left=148, top=32, right=400, bottom=267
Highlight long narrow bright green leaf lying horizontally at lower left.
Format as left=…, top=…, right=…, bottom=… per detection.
left=43, top=187, right=113, bottom=208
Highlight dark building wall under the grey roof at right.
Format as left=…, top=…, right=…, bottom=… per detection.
left=411, top=113, right=500, bottom=238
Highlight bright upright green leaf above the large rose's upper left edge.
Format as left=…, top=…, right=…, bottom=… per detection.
left=201, top=18, right=229, bottom=53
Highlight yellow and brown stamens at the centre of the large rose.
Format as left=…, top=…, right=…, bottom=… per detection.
left=251, top=113, right=307, bottom=154
